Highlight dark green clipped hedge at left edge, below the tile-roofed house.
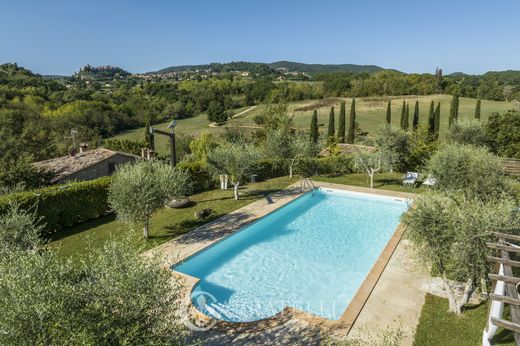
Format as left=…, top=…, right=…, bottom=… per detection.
left=0, top=177, right=110, bottom=234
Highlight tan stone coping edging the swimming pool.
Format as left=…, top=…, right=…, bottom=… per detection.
left=152, top=181, right=417, bottom=335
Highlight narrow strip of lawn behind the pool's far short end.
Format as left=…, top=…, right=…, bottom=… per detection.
left=312, top=173, right=428, bottom=193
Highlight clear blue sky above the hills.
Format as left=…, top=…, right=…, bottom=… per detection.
left=0, top=0, right=520, bottom=74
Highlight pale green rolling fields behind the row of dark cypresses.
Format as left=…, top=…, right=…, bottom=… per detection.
left=114, top=95, right=515, bottom=153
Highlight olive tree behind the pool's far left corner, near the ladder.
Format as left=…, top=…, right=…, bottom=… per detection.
left=264, top=127, right=316, bottom=179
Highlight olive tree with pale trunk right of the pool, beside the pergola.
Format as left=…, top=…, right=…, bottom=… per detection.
left=403, top=192, right=519, bottom=314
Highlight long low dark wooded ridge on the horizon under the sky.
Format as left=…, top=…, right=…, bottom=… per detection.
left=150, top=61, right=384, bottom=74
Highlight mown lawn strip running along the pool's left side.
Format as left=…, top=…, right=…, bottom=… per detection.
left=49, top=177, right=299, bottom=256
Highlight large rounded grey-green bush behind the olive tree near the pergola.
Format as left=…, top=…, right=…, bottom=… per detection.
left=428, top=144, right=511, bottom=200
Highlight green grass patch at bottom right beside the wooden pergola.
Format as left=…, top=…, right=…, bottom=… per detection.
left=414, top=294, right=515, bottom=346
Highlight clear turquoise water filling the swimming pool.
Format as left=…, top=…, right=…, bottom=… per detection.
left=175, top=189, right=407, bottom=322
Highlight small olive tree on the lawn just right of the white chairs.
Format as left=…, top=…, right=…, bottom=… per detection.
left=208, top=142, right=261, bottom=200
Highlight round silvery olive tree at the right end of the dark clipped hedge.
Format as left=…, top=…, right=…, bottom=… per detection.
left=108, top=160, right=191, bottom=238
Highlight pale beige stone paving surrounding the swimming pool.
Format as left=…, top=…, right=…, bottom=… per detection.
left=147, top=182, right=431, bottom=345
